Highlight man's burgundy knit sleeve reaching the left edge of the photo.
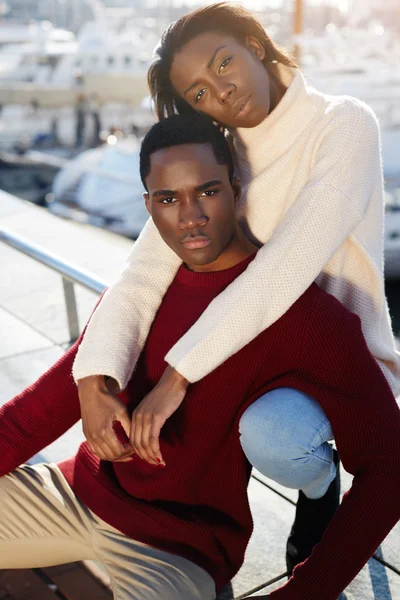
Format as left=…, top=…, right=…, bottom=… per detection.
left=0, top=340, right=80, bottom=477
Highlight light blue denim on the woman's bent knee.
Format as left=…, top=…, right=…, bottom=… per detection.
left=239, top=388, right=336, bottom=498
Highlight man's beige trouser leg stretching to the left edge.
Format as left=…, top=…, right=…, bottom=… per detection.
left=0, top=464, right=94, bottom=569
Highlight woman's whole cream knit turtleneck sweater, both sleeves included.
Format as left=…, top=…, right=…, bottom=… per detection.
left=73, top=70, right=400, bottom=395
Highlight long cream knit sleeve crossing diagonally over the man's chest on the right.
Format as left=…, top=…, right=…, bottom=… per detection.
left=165, top=101, right=383, bottom=382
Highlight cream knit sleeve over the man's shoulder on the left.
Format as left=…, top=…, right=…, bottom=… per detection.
left=73, top=219, right=181, bottom=389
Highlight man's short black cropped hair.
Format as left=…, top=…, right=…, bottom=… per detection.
left=140, top=115, right=234, bottom=190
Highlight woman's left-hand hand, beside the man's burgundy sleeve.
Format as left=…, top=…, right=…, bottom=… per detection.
left=78, top=375, right=134, bottom=462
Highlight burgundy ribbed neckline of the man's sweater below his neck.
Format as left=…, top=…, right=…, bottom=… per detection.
left=175, top=251, right=257, bottom=292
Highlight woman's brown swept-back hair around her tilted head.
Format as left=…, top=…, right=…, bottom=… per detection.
left=147, top=2, right=297, bottom=120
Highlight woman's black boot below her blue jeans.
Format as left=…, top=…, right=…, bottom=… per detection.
left=286, top=450, right=340, bottom=577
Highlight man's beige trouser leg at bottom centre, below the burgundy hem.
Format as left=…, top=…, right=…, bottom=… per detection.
left=93, top=517, right=215, bottom=600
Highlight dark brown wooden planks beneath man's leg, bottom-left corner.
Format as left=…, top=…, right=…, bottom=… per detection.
left=0, top=561, right=113, bottom=600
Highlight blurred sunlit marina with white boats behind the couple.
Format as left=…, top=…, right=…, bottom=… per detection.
left=0, top=0, right=400, bottom=335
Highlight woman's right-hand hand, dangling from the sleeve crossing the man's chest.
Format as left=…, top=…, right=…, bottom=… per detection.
left=130, top=366, right=189, bottom=467
